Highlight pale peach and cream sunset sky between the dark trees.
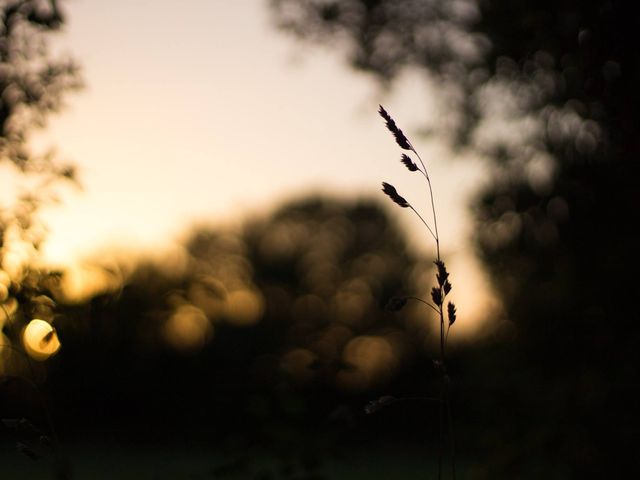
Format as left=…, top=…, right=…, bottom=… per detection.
left=30, top=0, right=496, bottom=334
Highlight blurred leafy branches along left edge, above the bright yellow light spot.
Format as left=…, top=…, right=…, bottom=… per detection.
left=0, top=0, right=81, bottom=371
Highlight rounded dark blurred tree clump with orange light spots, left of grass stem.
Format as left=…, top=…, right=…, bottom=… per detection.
left=56, top=198, right=433, bottom=422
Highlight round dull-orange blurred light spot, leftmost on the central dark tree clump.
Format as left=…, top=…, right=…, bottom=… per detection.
left=163, top=304, right=213, bottom=350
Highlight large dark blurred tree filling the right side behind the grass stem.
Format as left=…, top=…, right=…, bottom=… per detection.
left=271, top=0, right=640, bottom=478
